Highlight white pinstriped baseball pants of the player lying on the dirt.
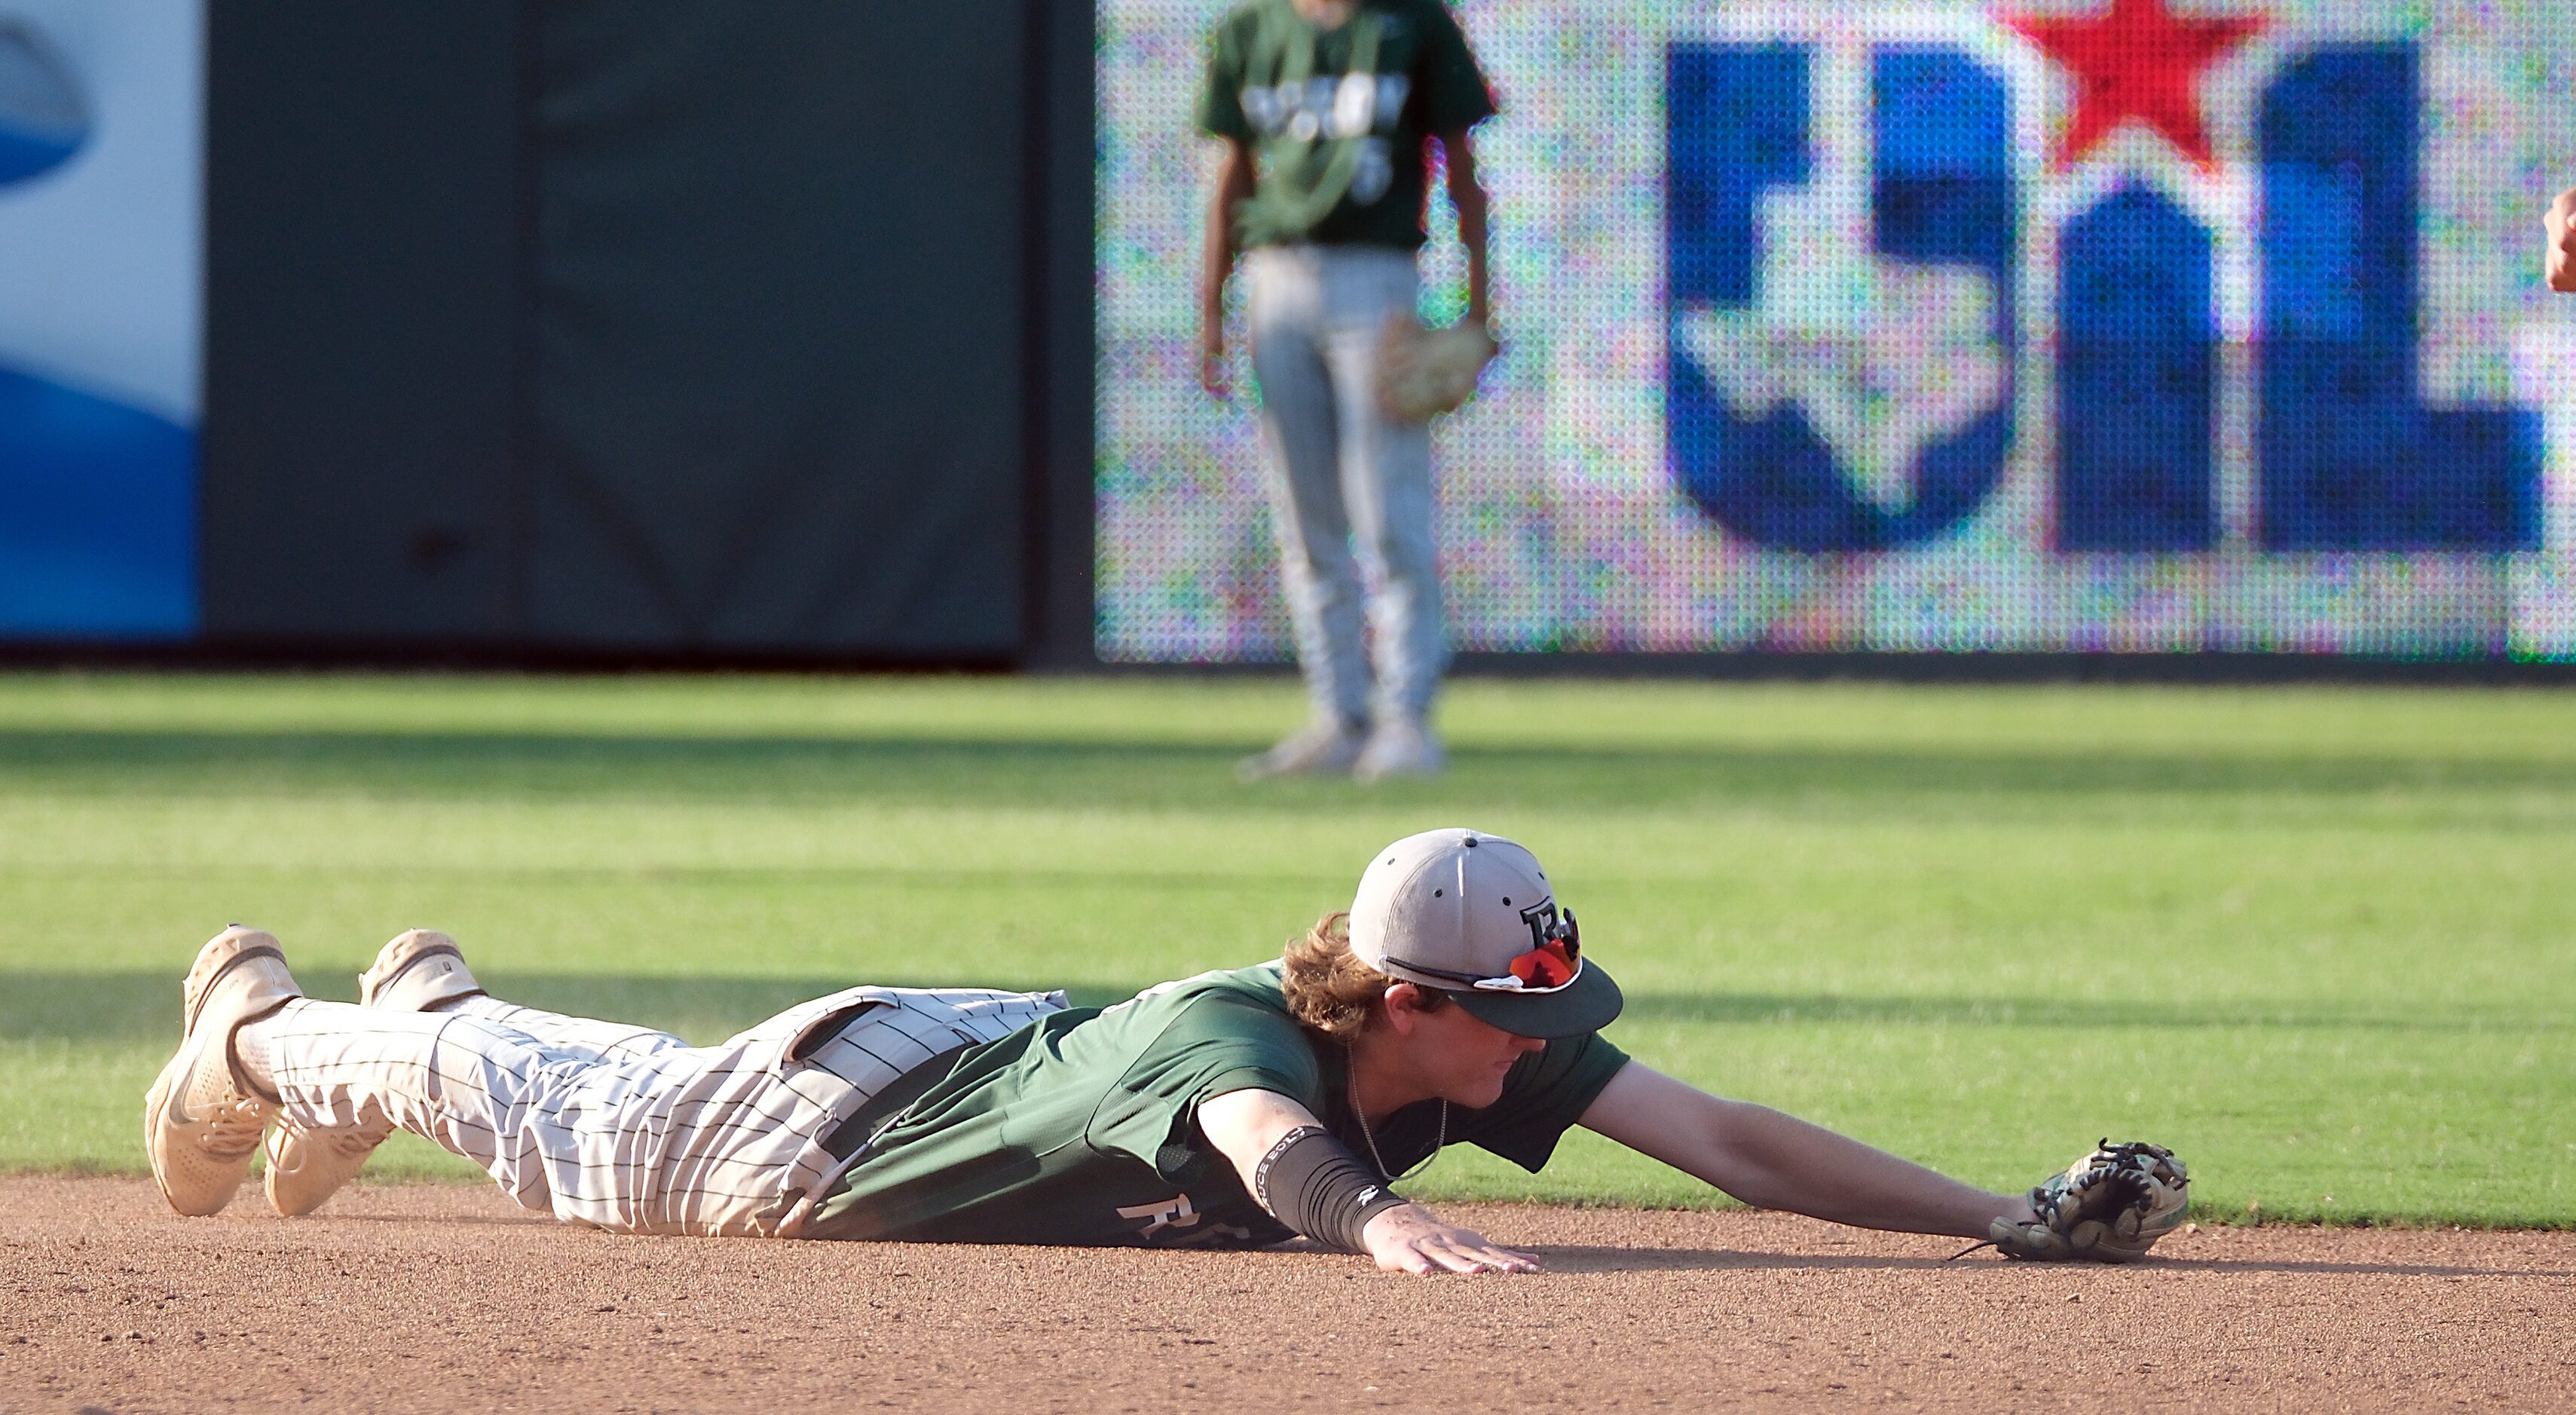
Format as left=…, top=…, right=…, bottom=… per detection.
left=263, top=987, right=1064, bottom=1235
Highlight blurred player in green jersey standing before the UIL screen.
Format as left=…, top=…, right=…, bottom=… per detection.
left=1198, top=0, right=1494, bottom=781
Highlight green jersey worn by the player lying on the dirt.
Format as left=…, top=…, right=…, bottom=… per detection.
left=803, top=964, right=1628, bottom=1248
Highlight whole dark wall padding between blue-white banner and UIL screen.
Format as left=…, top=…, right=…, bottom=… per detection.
left=206, top=0, right=1090, bottom=662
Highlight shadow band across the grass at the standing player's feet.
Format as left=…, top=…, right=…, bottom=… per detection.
left=0, top=729, right=2576, bottom=809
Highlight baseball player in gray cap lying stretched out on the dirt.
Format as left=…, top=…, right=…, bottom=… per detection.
left=144, top=830, right=2184, bottom=1273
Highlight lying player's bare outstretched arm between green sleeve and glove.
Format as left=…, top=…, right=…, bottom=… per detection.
left=1582, top=1062, right=2030, bottom=1239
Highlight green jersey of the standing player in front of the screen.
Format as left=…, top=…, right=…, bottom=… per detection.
left=1198, top=0, right=1494, bottom=250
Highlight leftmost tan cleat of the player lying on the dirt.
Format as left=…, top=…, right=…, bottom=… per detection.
left=144, top=925, right=304, bottom=1217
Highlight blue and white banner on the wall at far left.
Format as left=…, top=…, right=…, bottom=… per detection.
left=0, top=0, right=206, bottom=639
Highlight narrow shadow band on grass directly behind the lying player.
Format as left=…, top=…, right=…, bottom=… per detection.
left=15, top=969, right=2576, bottom=1041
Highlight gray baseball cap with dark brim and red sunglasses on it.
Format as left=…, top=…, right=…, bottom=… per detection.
left=1350, top=827, right=1623, bottom=1041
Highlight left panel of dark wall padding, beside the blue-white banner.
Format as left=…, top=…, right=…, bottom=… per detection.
left=198, top=0, right=520, bottom=642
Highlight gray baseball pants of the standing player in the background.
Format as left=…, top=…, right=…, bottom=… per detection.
left=1244, top=245, right=1448, bottom=722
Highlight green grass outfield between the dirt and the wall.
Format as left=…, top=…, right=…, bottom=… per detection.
left=0, top=675, right=2576, bottom=1227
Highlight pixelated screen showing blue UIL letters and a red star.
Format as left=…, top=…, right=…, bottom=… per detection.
left=1097, top=0, right=2576, bottom=662
